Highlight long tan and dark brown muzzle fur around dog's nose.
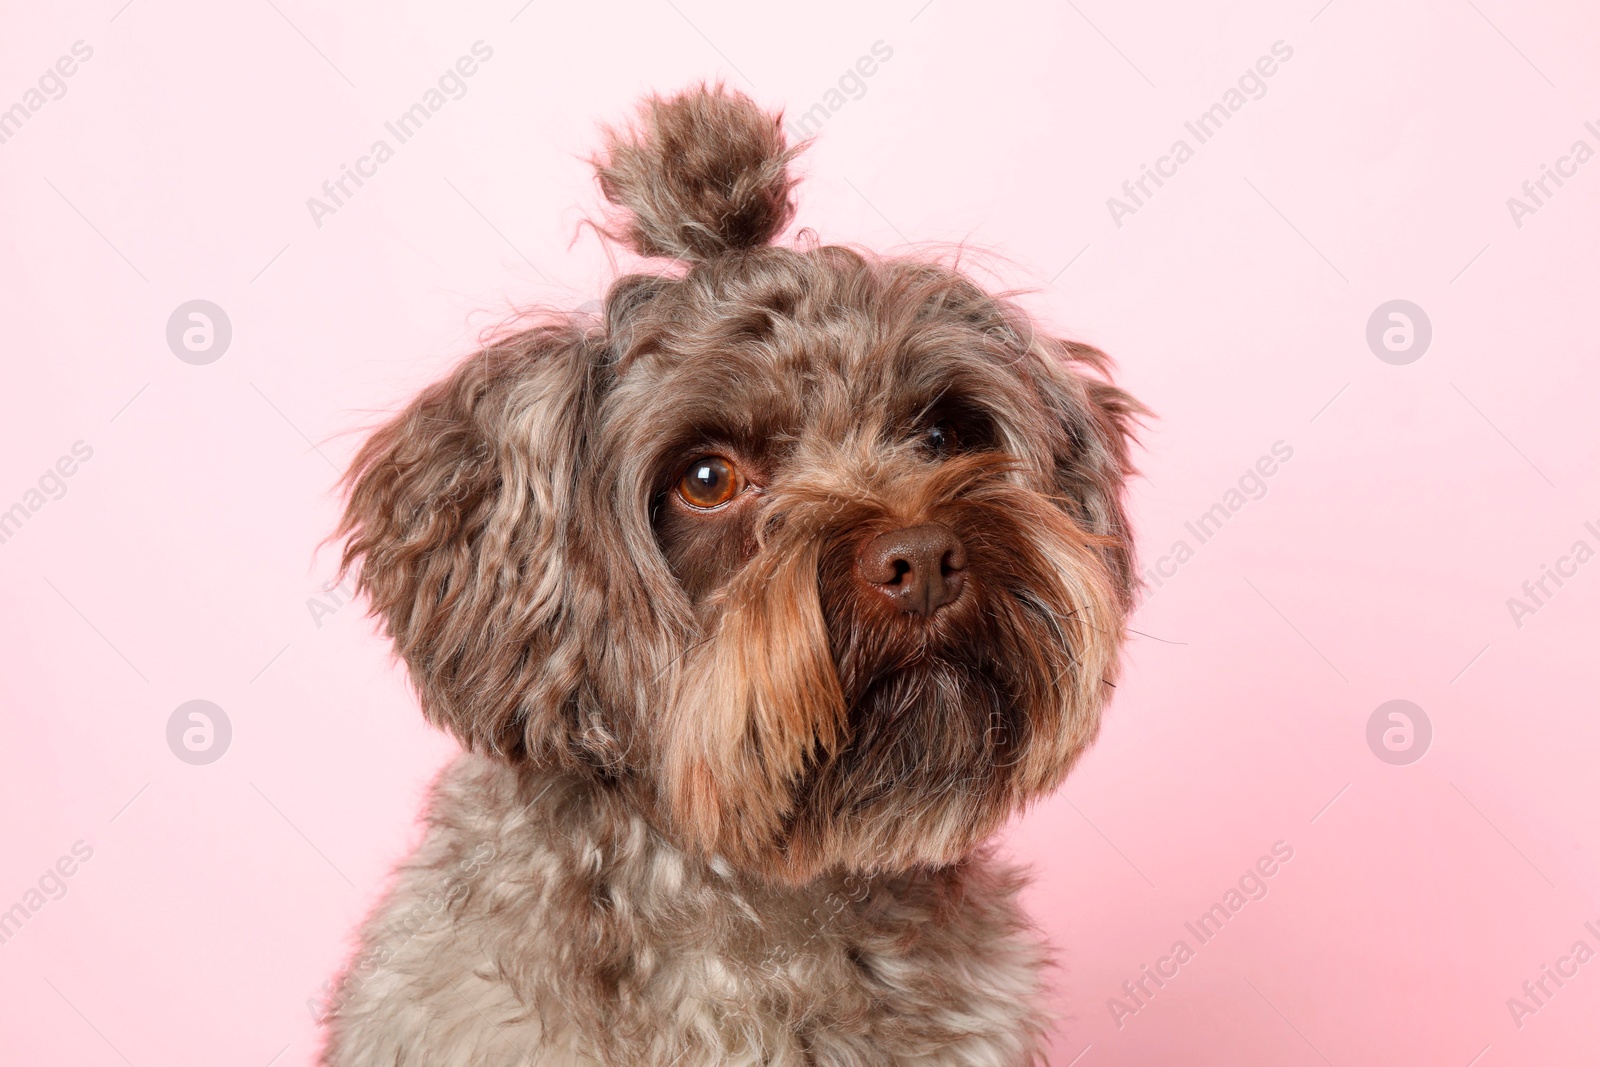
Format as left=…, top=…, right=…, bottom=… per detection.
left=664, top=458, right=1122, bottom=880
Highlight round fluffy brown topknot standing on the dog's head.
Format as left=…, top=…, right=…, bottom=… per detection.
left=594, top=85, right=803, bottom=262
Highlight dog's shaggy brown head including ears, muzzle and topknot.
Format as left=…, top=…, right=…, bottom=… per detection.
left=344, top=88, right=1139, bottom=880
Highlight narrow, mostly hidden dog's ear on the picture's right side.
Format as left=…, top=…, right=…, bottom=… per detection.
left=1032, top=338, right=1149, bottom=611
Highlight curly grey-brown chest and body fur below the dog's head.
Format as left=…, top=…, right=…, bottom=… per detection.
left=325, top=757, right=1043, bottom=1067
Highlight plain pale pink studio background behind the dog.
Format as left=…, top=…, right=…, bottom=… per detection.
left=0, top=0, right=1600, bottom=1067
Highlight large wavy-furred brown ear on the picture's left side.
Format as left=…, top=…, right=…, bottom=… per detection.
left=339, top=322, right=603, bottom=761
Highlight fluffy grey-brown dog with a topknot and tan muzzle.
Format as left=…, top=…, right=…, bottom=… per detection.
left=322, top=85, right=1144, bottom=1067
